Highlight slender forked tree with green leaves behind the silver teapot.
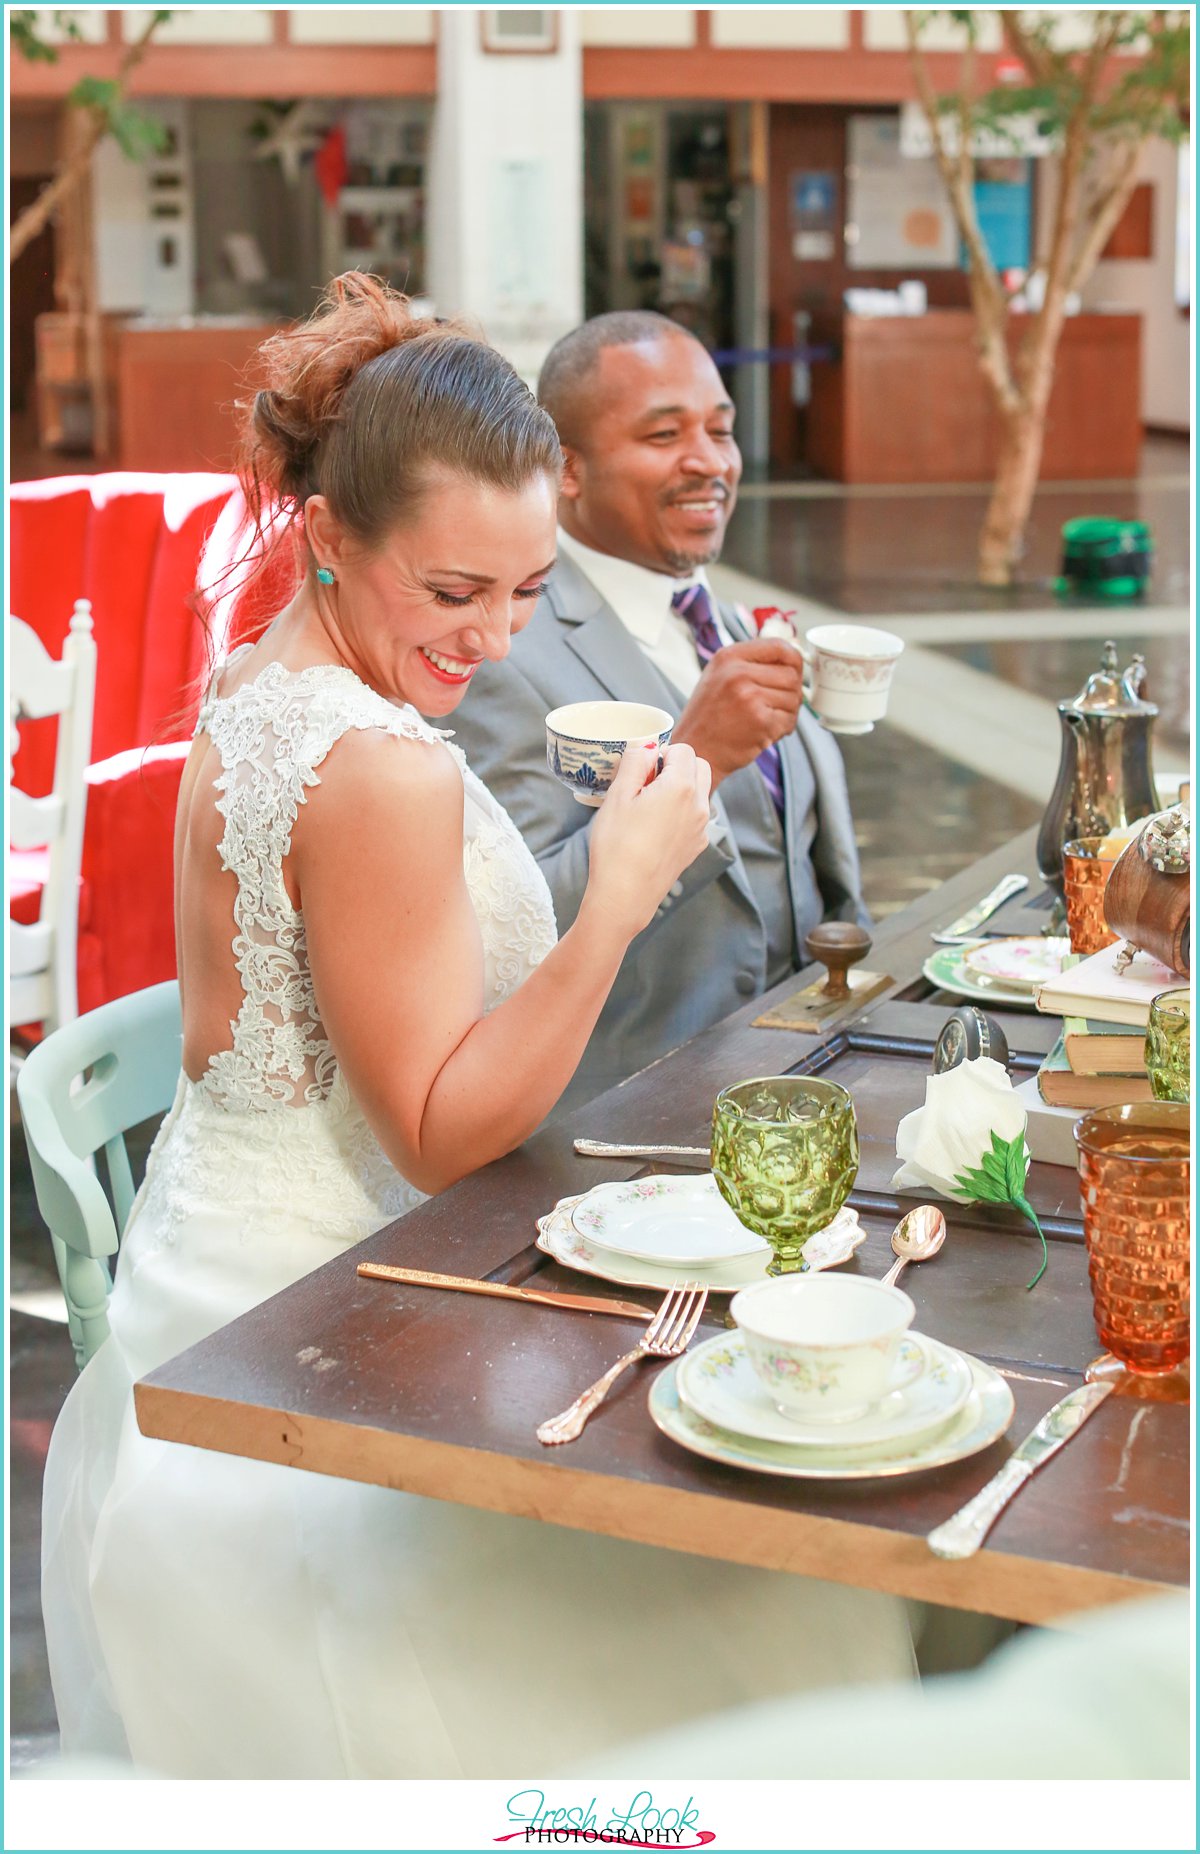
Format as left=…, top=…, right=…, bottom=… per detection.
left=905, top=9, right=1189, bottom=586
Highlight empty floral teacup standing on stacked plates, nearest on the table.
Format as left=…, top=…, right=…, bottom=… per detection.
left=729, top=1274, right=914, bottom=1422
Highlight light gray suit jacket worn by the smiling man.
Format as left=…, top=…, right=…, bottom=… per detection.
left=453, top=560, right=866, bottom=1105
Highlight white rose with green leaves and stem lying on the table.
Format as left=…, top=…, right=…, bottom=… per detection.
left=892, top=1057, right=1050, bottom=1287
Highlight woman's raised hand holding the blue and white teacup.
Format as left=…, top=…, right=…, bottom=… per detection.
left=584, top=745, right=712, bottom=940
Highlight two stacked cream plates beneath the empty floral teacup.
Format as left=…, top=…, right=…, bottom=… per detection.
left=649, top=1333, right=1013, bottom=1481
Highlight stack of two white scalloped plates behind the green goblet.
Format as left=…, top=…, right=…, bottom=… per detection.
left=538, top=1172, right=866, bottom=1294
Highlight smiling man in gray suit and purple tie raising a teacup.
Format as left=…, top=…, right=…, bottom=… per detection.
left=454, top=311, right=864, bottom=1103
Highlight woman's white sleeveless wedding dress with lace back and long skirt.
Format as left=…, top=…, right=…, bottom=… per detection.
left=43, top=664, right=913, bottom=1778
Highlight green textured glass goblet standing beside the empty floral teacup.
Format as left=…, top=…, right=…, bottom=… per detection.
left=712, top=1075, right=859, bottom=1276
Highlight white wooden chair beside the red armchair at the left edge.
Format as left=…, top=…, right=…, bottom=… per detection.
left=7, top=599, right=96, bottom=1035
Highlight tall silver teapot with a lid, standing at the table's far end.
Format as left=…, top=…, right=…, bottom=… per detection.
left=1037, top=640, right=1159, bottom=895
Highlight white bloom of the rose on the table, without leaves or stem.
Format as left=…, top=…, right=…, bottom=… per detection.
left=892, top=1057, right=1028, bottom=1203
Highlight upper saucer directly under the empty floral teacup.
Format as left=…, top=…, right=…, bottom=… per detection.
left=677, top=1333, right=972, bottom=1448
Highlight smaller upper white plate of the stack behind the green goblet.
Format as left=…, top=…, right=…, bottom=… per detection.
left=571, top=1172, right=770, bottom=1268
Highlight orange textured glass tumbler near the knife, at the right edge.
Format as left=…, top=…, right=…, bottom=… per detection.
left=1076, top=1101, right=1191, bottom=1376
